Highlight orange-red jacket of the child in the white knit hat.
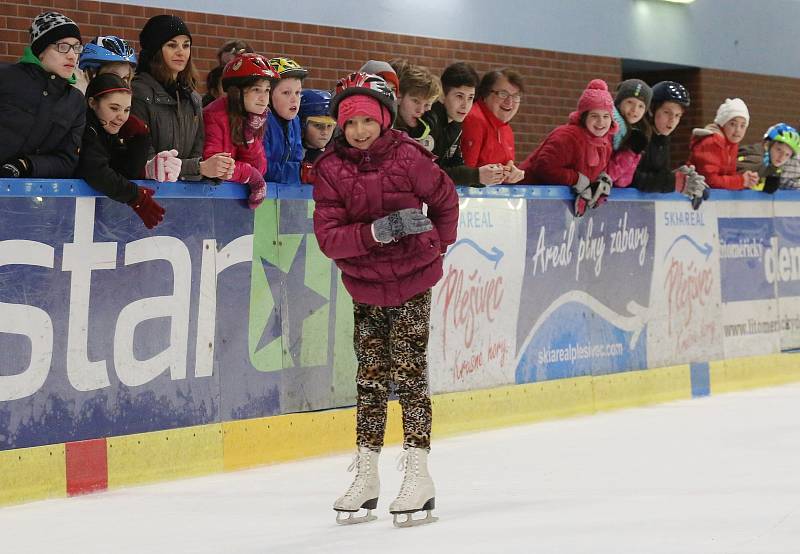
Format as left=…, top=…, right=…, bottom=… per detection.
left=687, top=125, right=744, bottom=190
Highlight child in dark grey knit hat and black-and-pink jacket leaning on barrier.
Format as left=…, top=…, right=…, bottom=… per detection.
left=606, top=79, right=653, bottom=187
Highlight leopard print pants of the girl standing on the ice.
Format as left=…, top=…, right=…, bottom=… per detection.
left=353, top=290, right=431, bottom=451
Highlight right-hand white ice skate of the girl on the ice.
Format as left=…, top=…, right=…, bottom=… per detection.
left=389, top=448, right=439, bottom=527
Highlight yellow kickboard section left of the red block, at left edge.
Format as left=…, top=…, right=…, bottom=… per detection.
left=0, top=444, right=67, bottom=506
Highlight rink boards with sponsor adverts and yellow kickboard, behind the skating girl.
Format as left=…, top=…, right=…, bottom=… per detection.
left=0, top=181, right=800, bottom=504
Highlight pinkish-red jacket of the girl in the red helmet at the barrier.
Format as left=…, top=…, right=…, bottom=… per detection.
left=203, top=96, right=267, bottom=183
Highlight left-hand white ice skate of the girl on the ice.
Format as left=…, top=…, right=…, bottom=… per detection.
left=333, top=446, right=381, bottom=525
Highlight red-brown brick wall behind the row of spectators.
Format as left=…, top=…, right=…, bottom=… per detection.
left=0, top=0, right=800, bottom=160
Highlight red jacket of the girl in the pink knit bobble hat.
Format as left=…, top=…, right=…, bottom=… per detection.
left=519, top=112, right=619, bottom=186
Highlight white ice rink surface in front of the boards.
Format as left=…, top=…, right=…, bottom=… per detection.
left=0, top=385, right=800, bottom=554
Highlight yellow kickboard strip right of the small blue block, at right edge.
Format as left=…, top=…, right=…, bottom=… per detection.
left=708, top=354, right=800, bottom=394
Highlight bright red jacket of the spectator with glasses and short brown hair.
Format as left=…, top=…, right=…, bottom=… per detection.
left=461, top=100, right=514, bottom=167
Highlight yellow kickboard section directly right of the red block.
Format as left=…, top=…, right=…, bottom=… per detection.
left=108, top=423, right=223, bottom=489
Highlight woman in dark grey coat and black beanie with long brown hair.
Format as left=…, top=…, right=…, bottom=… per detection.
left=132, top=15, right=234, bottom=181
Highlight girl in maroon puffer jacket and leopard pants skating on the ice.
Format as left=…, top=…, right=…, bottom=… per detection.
left=314, top=73, right=458, bottom=526
